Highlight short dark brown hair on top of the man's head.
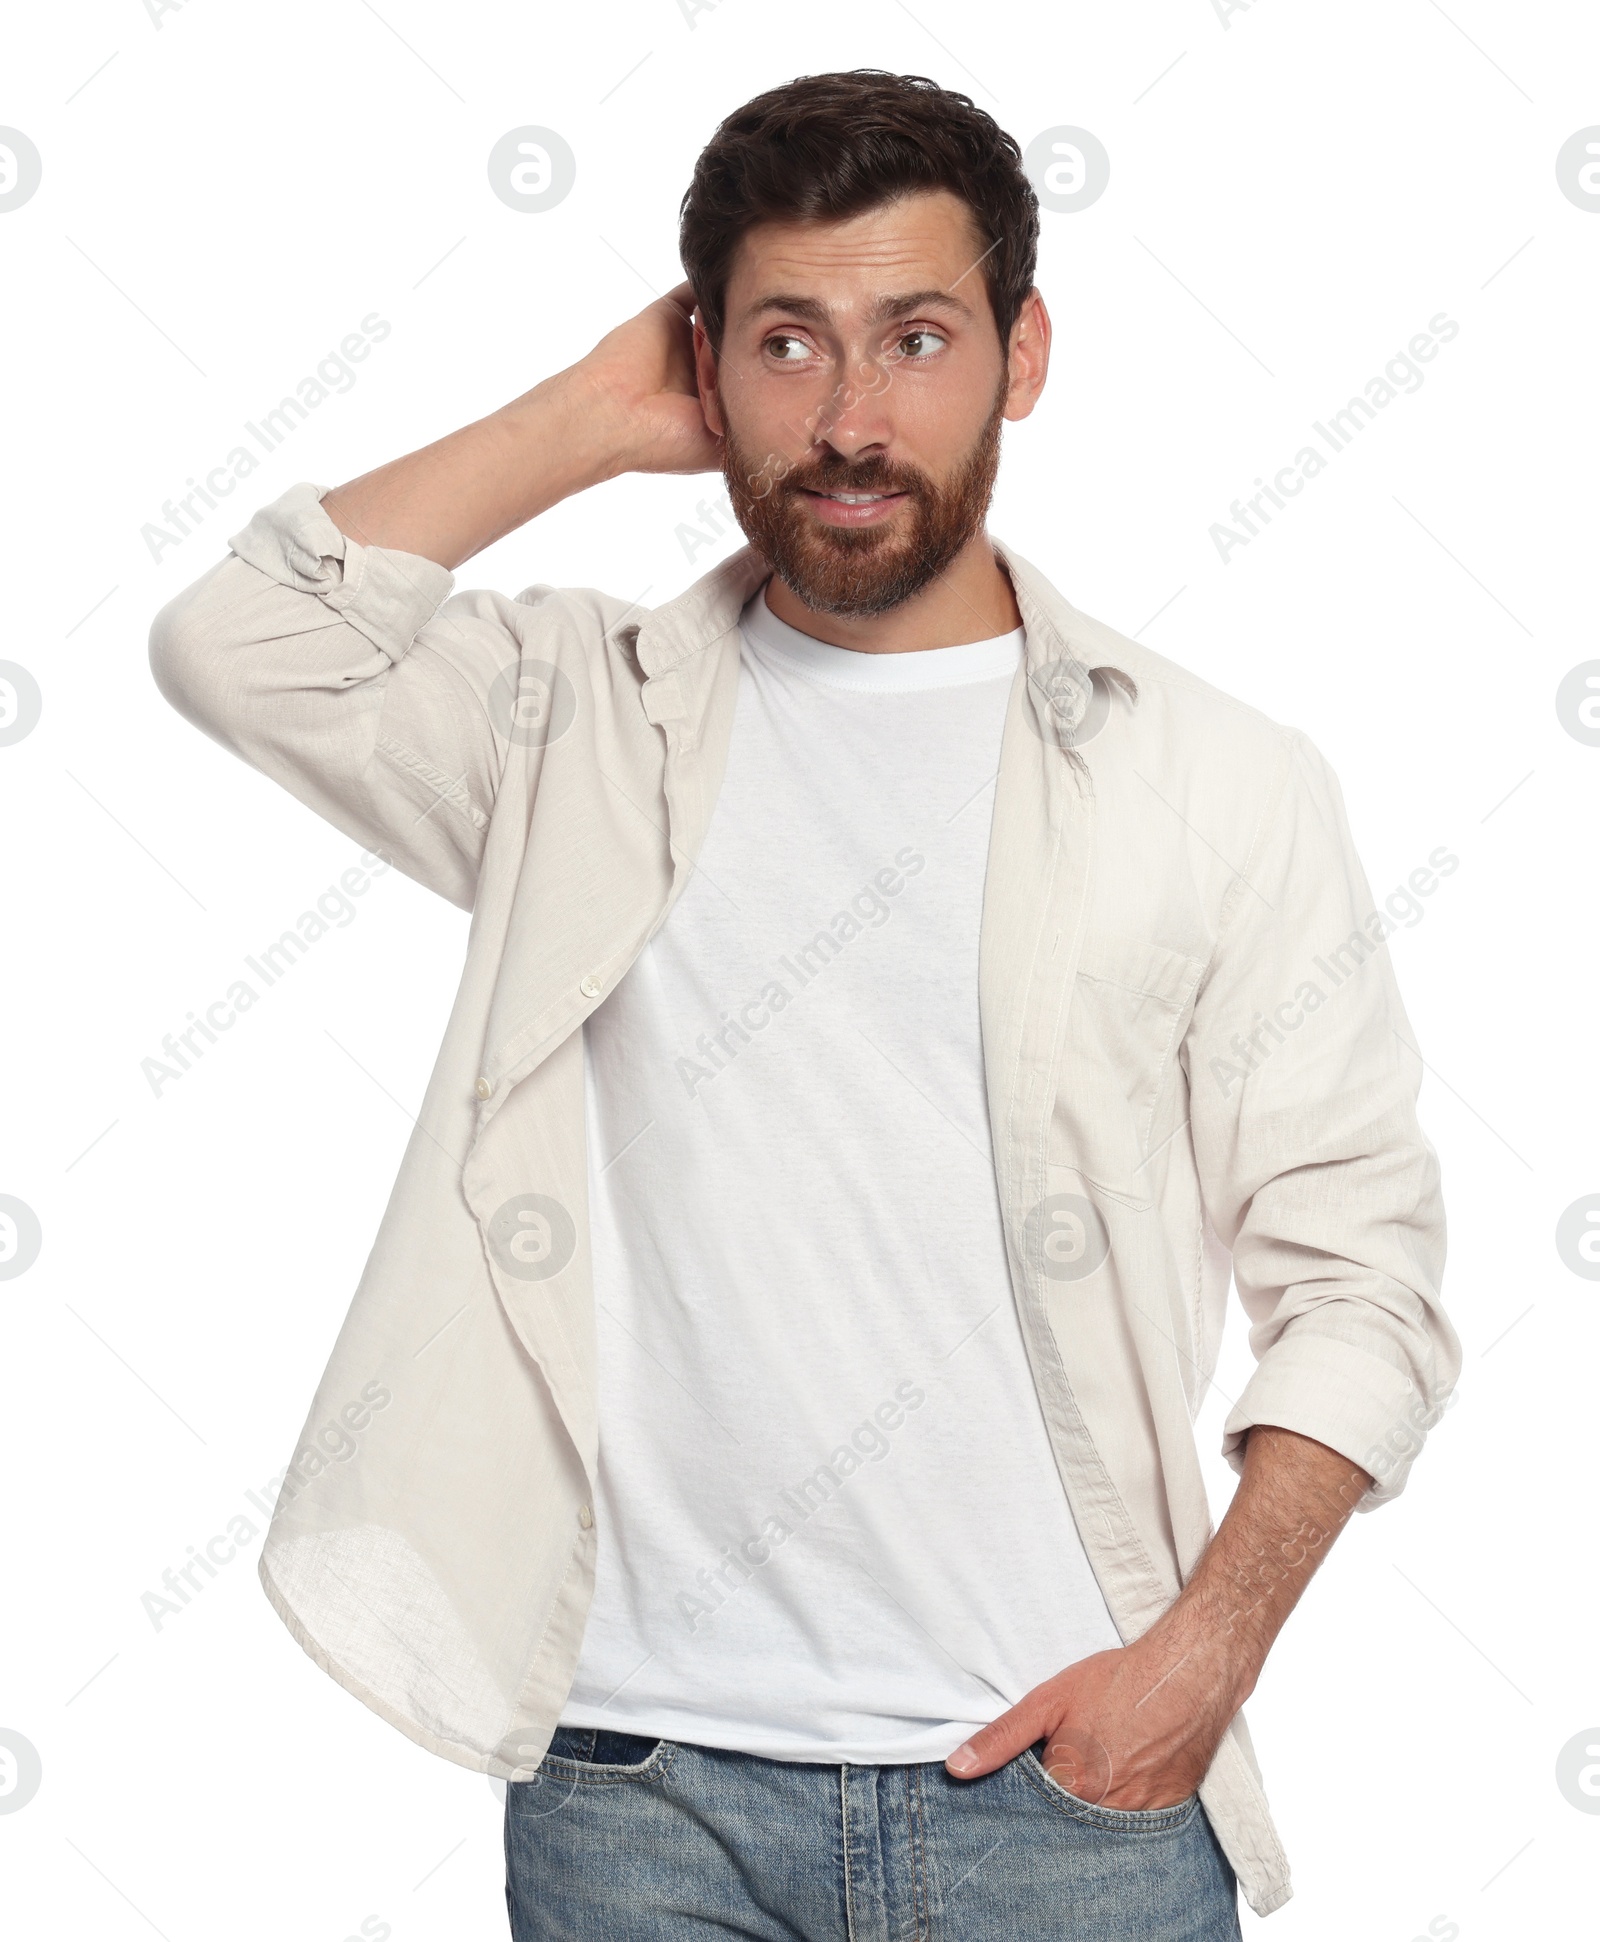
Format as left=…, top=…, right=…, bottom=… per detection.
left=678, top=68, right=1039, bottom=350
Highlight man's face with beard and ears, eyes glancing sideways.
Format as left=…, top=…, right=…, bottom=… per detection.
left=697, top=190, right=1049, bottom=616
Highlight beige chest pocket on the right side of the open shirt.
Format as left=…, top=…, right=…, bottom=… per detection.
left=1050, top=930, right=1204, bottom=1206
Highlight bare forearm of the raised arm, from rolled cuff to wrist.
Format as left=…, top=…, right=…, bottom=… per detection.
left=322, top=371, right=614, bottom=567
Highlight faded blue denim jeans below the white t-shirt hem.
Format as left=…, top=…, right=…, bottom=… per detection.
left=505, top=1726, right=1239, bottom=1942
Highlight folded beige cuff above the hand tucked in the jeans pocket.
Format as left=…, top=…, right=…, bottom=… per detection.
left=1221, top=1334, right=1454, bottom=1511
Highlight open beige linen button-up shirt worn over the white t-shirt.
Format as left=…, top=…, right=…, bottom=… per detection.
left=151, top=486, right=1460, bottom=1913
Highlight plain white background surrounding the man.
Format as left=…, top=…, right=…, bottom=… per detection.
left=0, top=0, right=1600, bottom=1942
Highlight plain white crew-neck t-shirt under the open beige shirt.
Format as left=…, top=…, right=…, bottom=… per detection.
left=561, top=578, right=1120, bottom=1763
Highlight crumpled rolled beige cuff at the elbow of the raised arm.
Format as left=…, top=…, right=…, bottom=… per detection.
left=227, top=484, right=456, bottom=660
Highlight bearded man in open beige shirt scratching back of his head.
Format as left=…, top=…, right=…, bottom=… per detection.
left=151, top=72, right=1458, bottom=1942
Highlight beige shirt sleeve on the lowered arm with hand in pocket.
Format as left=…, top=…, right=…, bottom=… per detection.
left=1184, top=734, right=1460, bottom=1509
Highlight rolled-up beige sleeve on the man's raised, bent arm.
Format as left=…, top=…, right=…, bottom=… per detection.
left=150, top=484, right=520, bottom=909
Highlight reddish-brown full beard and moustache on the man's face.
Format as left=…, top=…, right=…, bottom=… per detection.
left=722, top=385, right=1006, bottom=619
